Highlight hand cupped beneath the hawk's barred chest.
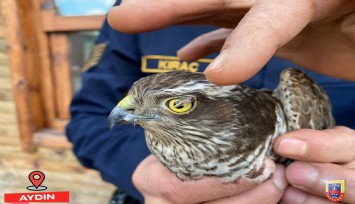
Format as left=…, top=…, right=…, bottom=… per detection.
left=132, top=155, right=288, bottom=204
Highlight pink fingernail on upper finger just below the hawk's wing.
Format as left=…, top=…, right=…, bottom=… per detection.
left=277, top=138, right=307, bottom=157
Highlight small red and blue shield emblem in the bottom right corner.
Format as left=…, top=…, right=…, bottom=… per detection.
left=325, top=180, right=345, bottom=202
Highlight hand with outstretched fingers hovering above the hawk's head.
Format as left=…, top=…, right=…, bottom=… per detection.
left=108, top=0, right=355, bottom=85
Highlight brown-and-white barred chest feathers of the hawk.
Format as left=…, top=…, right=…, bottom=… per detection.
left=145, top=104, right=287, bottom=183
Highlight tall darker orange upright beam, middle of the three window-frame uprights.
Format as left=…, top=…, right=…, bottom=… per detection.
left=16, top=0, right=55, bottom=131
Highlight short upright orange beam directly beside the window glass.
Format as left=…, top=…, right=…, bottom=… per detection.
left=49, top=33, right=72, bottom=119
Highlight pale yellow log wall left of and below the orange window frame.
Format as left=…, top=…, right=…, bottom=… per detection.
left=0, top=0, right=114, bottom=204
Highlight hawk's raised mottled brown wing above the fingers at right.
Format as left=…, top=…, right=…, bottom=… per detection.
left=272, top=68, right=335, bottom=130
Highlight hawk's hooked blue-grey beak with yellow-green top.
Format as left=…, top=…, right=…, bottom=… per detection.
left=107, top=95, right=157, bottom=129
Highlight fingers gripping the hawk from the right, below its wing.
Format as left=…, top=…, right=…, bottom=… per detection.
left=274, top=127, right=355, bottom=204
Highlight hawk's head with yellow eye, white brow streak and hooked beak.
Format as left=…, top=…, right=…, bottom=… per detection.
left=108, top=72, right=242, bottom=143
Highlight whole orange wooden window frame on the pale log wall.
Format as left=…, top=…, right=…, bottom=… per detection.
left=1, top=0, right=105, bottom=152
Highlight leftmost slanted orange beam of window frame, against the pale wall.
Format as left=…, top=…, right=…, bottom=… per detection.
left=0, top=0, right=36, bottom=152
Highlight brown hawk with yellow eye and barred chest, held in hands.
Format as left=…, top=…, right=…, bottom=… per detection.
left=108, top=68, right=335, bottom=182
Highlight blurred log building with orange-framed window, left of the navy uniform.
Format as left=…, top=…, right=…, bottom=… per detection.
left=0, top=0, right=114, bottom=204
